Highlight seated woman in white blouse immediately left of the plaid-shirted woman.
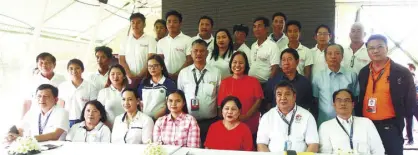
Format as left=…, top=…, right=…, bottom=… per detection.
left=112, top=88, right=154, bottom=144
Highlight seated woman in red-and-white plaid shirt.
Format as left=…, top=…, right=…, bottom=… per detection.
left=153, top=90, right=200, bottom=148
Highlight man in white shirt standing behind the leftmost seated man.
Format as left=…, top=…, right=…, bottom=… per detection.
left=22, top=52, right=65, bottom=117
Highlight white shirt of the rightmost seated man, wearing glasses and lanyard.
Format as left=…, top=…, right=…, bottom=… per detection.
left=319, top=116, right=385, bottom=155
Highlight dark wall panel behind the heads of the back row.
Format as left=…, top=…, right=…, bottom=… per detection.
left=162, top=0, right=335, bottom=48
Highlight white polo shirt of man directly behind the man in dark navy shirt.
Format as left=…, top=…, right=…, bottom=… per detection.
left=280, top=43, right=313, bottom=76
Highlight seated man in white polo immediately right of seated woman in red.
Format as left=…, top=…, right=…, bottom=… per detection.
left=257, top=81, right=319, bottom=152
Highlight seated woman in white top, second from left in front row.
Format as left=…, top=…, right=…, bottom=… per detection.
left=66, top=100, right=111, bottom=143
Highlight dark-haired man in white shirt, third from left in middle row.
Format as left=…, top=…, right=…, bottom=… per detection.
left=86, top=46, right=113, bottom=91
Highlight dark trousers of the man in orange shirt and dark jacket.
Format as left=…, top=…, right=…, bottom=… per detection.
left=373, top=119, right=404, bottom=155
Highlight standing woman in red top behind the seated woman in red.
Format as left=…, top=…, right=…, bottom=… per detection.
left=218, top=51, right=264, bottom=139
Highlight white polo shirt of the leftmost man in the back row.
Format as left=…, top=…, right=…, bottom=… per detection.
left=119, top=33, right=157, bottom=75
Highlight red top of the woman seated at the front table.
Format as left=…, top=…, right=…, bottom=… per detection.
left=205, top=120, right=253, bottom=151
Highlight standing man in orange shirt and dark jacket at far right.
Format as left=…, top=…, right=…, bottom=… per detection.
left=355, top=34, right=416, bottom=155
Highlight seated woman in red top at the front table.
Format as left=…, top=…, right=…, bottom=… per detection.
left=205, top=96, right=254, bottom=151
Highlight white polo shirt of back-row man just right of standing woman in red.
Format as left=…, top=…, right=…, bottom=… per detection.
left=248, top=39, right=280, bottom=83
